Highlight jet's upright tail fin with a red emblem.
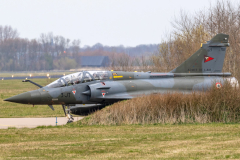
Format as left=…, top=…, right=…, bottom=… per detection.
left=171, top=33, right=229, bottom=73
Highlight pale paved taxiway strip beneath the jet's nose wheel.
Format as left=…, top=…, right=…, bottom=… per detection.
left=0, top=117, right=83, bottom=129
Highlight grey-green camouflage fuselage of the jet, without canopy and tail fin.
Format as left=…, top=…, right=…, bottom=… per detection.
left=8, top=71, right=231, bottom=105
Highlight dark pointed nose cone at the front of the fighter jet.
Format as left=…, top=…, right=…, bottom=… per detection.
left=4, top=92, right=31, bottom=104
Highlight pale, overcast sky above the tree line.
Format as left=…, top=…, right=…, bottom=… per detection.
left=0, top=0, right=215, bottom=47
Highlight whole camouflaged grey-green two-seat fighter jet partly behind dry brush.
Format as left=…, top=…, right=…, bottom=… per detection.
left=5, top=34, right=238, bottom=122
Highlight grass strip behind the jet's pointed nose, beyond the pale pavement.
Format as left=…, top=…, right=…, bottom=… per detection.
left=0, top=79, right=64, bottom=118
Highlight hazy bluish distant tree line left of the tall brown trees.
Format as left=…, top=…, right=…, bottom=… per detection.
left=0, top=25, right=158, bottom=71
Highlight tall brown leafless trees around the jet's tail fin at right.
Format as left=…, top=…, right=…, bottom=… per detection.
left=152, top=0, right=240, bottom=78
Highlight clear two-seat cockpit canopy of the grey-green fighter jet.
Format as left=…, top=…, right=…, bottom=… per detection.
left=47, top=71, right=108, bottom=88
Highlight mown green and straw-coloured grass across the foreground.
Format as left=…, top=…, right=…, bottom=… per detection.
left=0, top=123, right=240, bottom=159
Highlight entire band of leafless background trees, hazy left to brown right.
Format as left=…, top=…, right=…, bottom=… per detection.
left=0, top=0, right=240, bottom=76
